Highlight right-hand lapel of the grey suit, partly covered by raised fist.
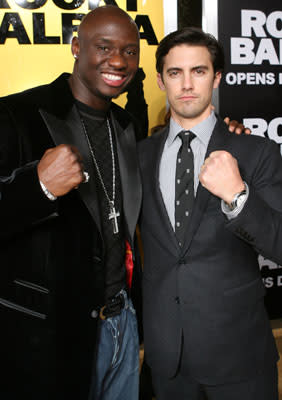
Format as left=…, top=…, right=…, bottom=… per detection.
left=183, top=119, right=230, bottom=253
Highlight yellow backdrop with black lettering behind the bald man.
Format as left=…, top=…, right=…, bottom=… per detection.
left=0, top=0, right=177, bottom=127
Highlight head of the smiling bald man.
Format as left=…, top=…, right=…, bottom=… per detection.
left=70, top=6, right=139, bottom=109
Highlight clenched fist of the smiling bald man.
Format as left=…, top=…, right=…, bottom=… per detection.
left=37, top=144, right=84, bottom=197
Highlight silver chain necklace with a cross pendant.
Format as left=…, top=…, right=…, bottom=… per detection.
left=80, top=118, right=120, bottom=234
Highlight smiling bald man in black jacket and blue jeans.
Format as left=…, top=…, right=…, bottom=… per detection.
left=0, top=6, right=141, bottom=400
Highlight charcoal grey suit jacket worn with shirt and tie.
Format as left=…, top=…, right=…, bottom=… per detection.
left=139, top=120, right=282, bottom=384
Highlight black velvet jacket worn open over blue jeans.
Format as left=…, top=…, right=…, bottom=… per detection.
left=0, top=74, right=141, bottom=400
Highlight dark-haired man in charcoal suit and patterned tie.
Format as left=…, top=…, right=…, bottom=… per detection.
left=139, top=28, right=282, bottom=400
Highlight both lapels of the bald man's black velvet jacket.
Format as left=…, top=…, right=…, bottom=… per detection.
left=40, top=74, right=142, bottom=237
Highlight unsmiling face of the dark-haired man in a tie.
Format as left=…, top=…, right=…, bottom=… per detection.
left=157, top=44, right=221, bottom=129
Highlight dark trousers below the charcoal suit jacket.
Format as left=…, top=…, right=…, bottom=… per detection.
left=153, top=364, right=278, bottom=400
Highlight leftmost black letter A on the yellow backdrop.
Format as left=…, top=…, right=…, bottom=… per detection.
left=0, top=13, right=31, bottom=44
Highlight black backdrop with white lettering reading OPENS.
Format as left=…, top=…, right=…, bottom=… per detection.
left=203, top=0, right=282, bottom=318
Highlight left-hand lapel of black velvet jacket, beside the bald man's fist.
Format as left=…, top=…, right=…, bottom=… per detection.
left=39, top=104, right=101, bottom=231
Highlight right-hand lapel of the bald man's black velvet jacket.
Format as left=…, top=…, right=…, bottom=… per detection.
left=111, top=112, right=142, bottom=238
